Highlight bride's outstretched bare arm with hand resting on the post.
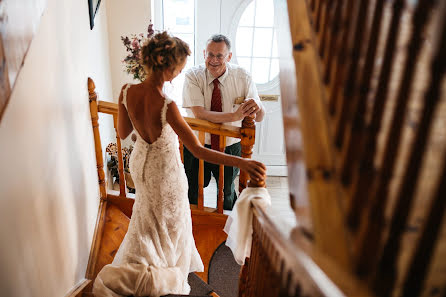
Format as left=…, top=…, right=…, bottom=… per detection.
left=167, top=102, right=266, bottom=179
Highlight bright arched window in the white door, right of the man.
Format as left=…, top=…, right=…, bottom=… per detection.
left=235, top=0, right=279, bottom=85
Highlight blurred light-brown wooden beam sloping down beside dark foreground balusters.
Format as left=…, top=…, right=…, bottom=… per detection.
left=280, top=0, right=351, bottom=270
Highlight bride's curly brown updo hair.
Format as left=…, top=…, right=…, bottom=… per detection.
left=141, top=31, right=191, bottom=74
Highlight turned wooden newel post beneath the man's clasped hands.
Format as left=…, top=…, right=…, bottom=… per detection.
left=239, top=117, right=256, bottom=193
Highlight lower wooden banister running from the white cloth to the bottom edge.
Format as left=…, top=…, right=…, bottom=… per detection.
left=239, top=199, right=373, bottom=297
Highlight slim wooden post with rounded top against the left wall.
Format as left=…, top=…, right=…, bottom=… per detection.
left=88, top=78, right=107, bottom=199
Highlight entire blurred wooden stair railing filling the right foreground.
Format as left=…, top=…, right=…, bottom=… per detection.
left=239, top=0, right=446, bottom=297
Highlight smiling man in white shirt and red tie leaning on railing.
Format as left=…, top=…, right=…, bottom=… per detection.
left=183, top=34, right=265, bottom=210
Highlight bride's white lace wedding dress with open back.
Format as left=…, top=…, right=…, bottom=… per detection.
left=93, top=85, right=203, bottom=297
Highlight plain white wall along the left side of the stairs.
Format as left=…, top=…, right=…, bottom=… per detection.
left=0, top=0, right=112, bottom=297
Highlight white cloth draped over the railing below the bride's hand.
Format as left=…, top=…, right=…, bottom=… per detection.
left=224, top=188, right=271, bottom=265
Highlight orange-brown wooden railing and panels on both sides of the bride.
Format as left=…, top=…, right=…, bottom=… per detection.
left=82, top=78, right=255, bottom=296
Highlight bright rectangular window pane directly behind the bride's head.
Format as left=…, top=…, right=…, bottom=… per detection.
left=162, top=0, right=195, bottom=105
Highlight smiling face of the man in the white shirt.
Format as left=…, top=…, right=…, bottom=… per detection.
left=203, top=41, right=232, bottom=78
